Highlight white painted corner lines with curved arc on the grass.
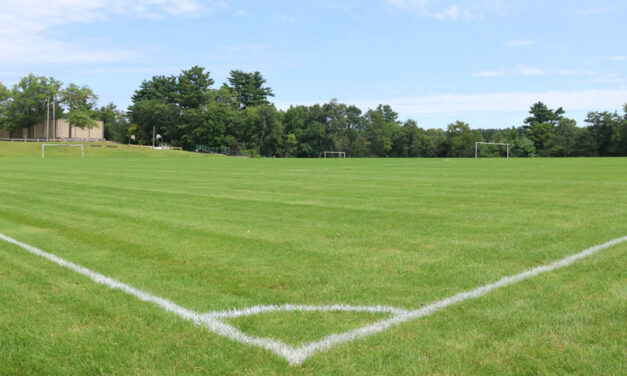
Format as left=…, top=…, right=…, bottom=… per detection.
left=0, top=233, right=627, bottom=365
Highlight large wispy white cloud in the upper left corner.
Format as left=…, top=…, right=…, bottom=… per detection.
left=0, top=0, right=222, bottom=64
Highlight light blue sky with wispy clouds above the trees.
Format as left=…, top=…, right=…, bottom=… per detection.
left=0, top=0, right=627, bottom=128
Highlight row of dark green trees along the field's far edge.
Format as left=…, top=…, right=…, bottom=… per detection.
left=0, top=66, right=627, bottom=157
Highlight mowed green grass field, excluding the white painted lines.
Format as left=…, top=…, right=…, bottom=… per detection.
left=0, top=142, right=627, bottom=375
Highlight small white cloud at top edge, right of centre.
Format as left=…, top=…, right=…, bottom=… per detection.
left=388, top=0, right=504, bottom=21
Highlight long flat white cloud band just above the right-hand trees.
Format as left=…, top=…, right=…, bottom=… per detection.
left=276, top=89, right=627, bottom=117
